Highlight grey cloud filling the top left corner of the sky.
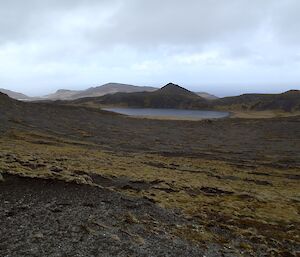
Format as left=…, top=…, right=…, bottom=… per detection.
left=0, top=0, right=115, bottom=44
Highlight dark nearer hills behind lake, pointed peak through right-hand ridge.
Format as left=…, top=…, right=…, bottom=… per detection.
left=68, top=83, right=300, bottom=112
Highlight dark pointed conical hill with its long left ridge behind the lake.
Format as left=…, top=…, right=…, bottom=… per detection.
left=72, top=83, right=207, bottom=109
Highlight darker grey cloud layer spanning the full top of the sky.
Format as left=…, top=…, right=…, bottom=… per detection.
left=0, top=0, right=300, bottom=46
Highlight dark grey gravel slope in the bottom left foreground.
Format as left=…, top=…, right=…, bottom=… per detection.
left=0, top=175, right=239, bottom=257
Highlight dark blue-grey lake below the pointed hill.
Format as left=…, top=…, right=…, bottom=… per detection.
left=104, top=108, right=229, bottom=120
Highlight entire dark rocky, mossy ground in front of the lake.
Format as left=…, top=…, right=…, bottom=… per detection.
left=0, top=91, right=300, bottom=256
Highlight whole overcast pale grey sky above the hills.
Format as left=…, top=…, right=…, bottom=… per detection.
left=0, top=0, right=300, bottom=96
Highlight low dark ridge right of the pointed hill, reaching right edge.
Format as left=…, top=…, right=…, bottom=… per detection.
left=213, top=90, right=300, bottom=112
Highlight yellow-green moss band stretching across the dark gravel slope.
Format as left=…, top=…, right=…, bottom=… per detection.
left=0, top=127, right=300, bottom=250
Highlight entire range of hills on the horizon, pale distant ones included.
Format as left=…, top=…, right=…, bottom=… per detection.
left=0, top=83, right=300, bottom=112
